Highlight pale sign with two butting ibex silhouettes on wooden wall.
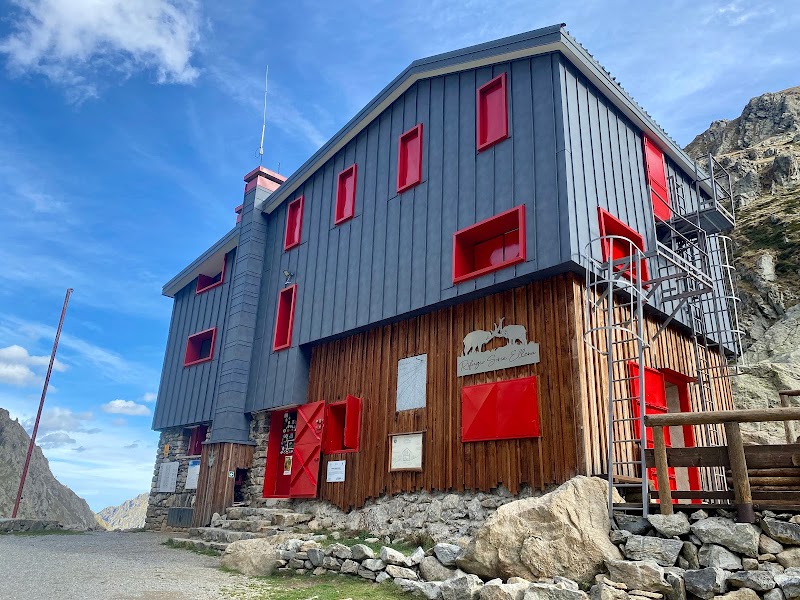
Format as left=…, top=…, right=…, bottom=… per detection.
left=458, top=318, right=539, bottom=377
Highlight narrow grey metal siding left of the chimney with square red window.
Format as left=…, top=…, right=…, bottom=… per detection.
left=153, top=250, right=236, bottom=429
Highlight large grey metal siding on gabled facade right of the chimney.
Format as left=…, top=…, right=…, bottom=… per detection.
left=248, top=54, right=571, bottom=411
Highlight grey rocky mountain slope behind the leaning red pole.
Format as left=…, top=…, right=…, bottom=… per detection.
left=0, top=408, right=97, bottom=529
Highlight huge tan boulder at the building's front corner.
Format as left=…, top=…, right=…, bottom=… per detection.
left=457, top=476, right=622, bottom=583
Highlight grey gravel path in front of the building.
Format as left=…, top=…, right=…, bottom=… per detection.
left=0, top=533, right=255, bottom=600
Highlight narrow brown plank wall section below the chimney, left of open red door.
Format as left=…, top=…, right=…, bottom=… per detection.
left=192, top=444, right=253, bottom=527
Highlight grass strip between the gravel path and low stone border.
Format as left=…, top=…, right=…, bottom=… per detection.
left=224, top=575, right=407, bottom=600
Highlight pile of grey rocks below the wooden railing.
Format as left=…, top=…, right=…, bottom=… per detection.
left=598, top=510, right=800, bottom=600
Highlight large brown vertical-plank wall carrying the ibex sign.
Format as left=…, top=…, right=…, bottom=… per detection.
left=308, top=275, right=585, bottom=509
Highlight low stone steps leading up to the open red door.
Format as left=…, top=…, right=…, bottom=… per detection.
left=171, top=502, right=313, bottom=552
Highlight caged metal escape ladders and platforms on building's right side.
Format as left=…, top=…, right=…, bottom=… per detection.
left=585, top=156, right=742, bottom=516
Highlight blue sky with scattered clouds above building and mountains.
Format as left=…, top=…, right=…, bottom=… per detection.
left=0, top=0, right=800, bottom=510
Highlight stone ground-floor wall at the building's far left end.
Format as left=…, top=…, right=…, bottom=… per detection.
left=144, top=427, right=211, bottom=531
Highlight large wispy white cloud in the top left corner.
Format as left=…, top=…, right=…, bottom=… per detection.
left=0, top=0, right=200, bottom=100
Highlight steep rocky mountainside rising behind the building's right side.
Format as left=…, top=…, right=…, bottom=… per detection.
left=686, top=87, right=800, bottom=443
